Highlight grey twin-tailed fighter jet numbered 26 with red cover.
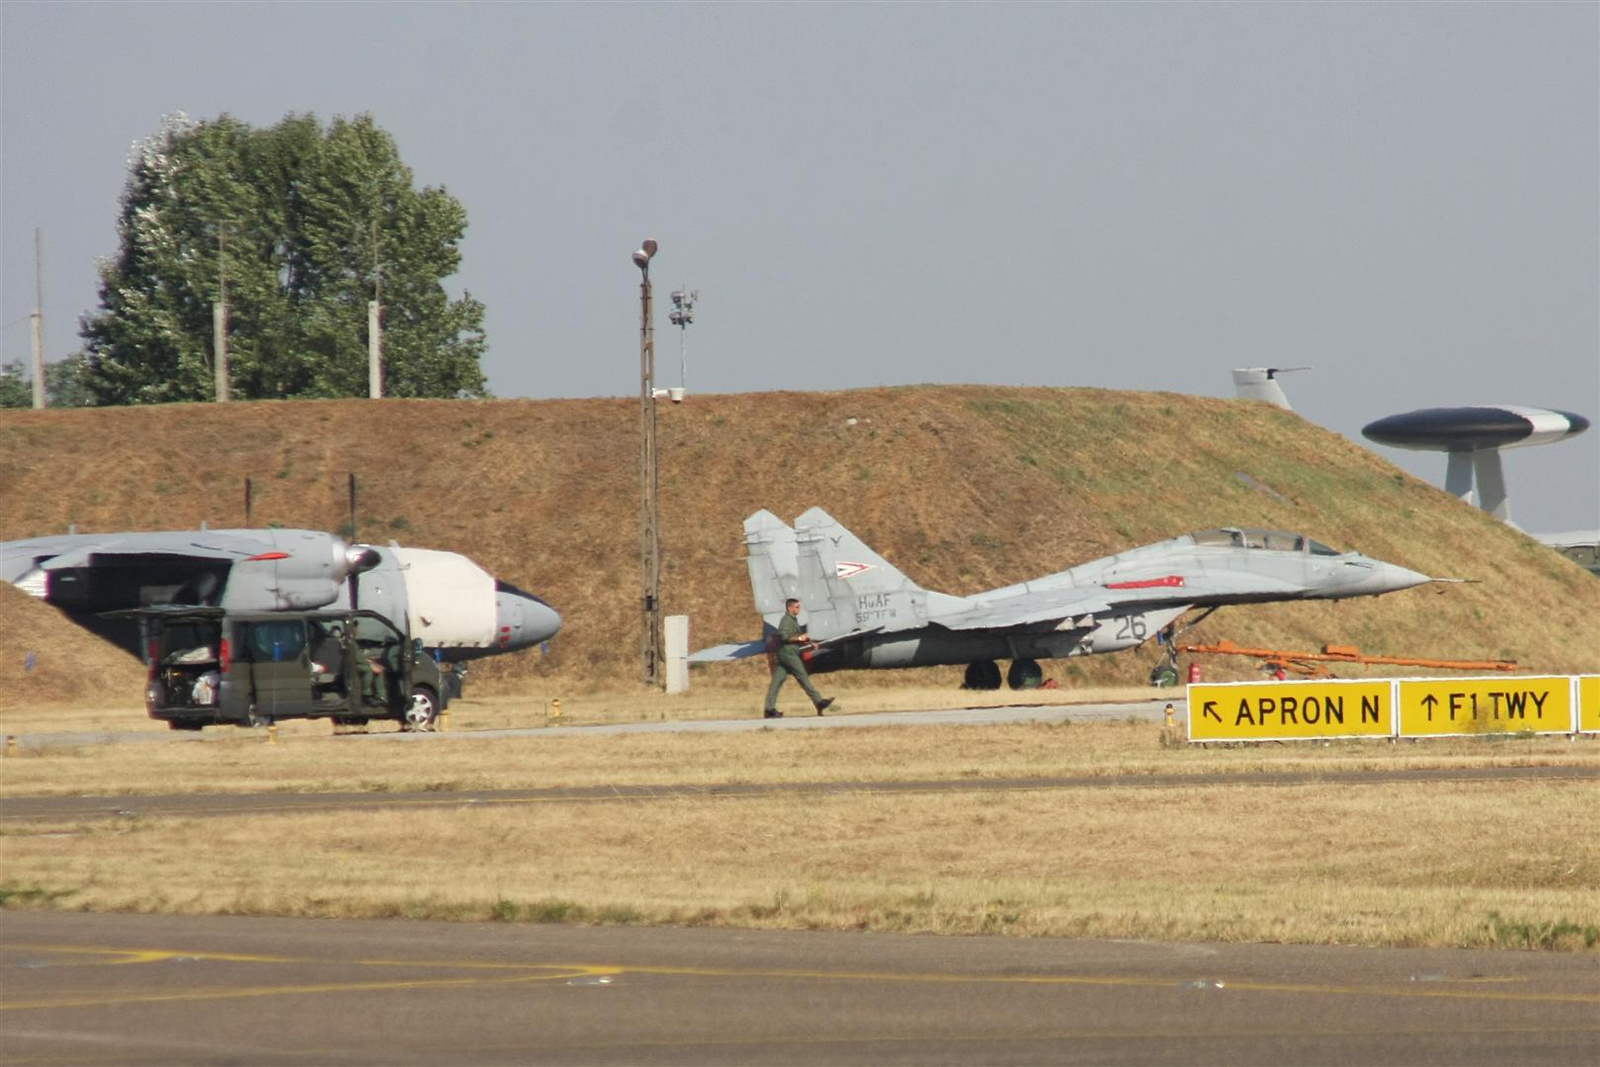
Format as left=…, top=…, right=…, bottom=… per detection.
left=690, top=507, right=1435, bottom=689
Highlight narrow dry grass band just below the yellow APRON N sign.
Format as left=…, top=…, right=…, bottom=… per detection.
left=0, top=721, right=1594, bottom=797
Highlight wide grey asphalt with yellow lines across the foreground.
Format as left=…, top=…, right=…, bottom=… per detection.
left=0, top=912, right=1600, bottom=1067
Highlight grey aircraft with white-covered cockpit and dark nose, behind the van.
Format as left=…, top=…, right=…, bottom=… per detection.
left=0, top=530, right=562, bottom=661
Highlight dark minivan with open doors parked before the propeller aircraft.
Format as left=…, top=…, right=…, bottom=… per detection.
left=131, top=606, right=448, bottom=729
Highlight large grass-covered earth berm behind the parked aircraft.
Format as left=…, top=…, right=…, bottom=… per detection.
left=0, top=386, right=1600, bottom=705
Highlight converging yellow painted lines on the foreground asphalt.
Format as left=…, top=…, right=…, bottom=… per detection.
left=0, top=945, right=1600, bottom=1011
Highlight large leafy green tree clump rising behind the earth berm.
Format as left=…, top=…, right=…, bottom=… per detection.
left=80, top=115, right=486, bottom=403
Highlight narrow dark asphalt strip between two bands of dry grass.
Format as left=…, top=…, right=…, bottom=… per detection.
left=0, top=765, right=1600, bottom=830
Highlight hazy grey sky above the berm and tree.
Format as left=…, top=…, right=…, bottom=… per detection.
left=0, top=0, right=1600, bottom=530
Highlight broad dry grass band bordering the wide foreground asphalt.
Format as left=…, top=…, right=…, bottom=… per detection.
left=0, top=782, right=1600, bottom=949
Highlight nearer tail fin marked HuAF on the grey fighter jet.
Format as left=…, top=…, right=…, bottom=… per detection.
left=795, top=507, right=954, bottom=641
